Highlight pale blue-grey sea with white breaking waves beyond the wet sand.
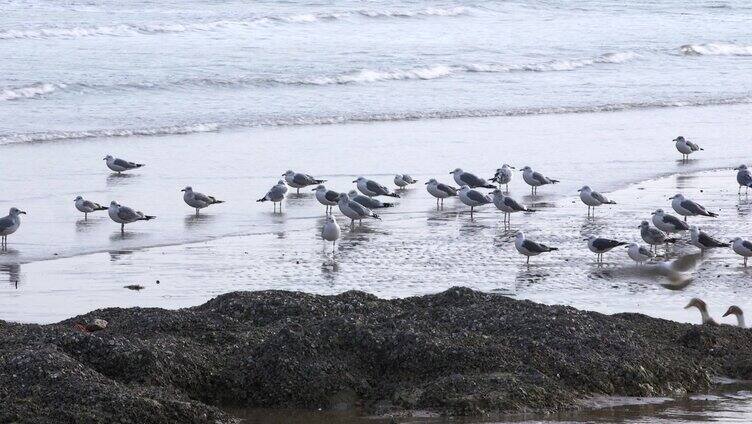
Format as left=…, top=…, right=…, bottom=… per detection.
left=0, top=0, right=752, bottom=144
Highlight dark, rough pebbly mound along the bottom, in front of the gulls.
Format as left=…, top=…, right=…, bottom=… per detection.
left=0, top=288, right=752, bottom=423
